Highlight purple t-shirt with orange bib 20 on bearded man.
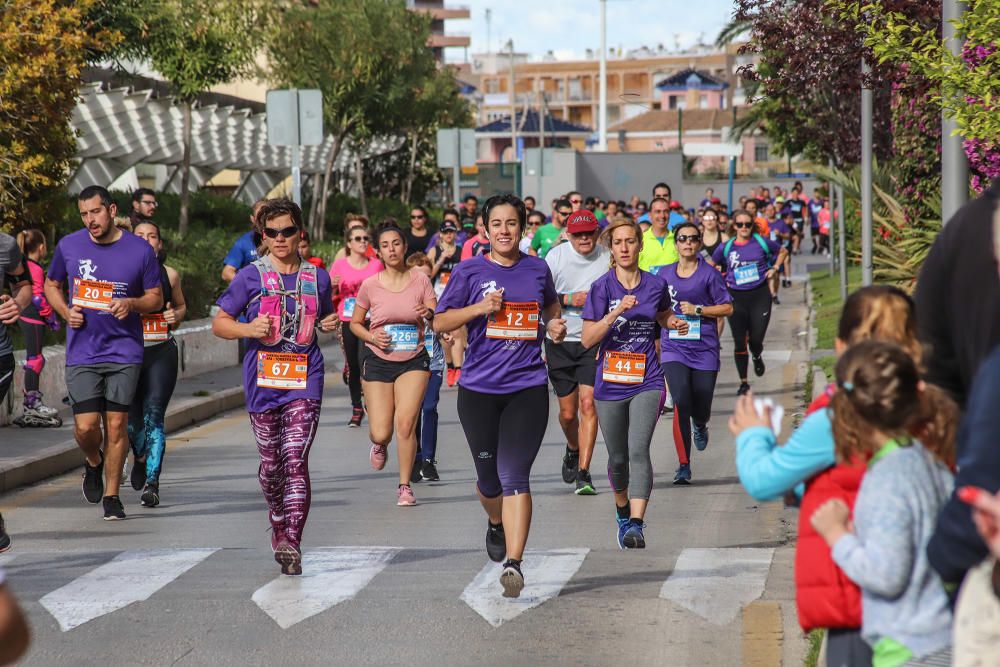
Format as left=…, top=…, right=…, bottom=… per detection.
left=49, top=229, right=161, bottom=366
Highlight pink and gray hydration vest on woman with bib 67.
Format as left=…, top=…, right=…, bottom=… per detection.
left=253, top=255, right=319, bottom=346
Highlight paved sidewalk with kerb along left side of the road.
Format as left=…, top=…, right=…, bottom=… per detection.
left=0, top=338, right=342, bottom=493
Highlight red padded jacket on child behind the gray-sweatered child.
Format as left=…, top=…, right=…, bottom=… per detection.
left=795, top=385, right=865, bottom=632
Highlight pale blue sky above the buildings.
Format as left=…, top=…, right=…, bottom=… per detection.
left=445, top=0, right=733, bottom=62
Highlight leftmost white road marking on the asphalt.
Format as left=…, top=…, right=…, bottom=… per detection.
left=39, top=549, right=218, bottom=632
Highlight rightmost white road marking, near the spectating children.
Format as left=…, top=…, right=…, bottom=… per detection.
left=660, top=548, right=774, bottom=625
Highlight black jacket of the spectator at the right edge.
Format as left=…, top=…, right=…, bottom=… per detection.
left=914, top=178, right=1000, bottom=406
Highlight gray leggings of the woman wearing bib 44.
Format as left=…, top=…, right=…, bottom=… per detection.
left=594, top=389, right=663, bottom=500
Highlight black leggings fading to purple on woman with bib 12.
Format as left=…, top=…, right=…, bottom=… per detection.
left=458, top=384, right=549, bottom=498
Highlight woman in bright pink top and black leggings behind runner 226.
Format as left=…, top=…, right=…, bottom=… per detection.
left=330, top=224, right=382, bottom=428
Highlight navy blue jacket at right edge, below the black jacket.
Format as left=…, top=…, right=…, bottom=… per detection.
left=927, top=346, right=1000, bottom=585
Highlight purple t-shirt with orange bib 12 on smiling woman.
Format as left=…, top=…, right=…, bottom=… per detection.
left=436, top=255, right=559, bottom=394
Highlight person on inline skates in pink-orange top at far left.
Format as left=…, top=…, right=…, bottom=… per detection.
left=14, top=229, right=62, bottom=427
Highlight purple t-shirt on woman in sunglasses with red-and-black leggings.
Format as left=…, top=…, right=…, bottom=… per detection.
left=659, top=258, right=733, bottom=371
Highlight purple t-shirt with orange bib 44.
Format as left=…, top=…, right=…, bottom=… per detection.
left=583, top=269, right=670, bottom=401
